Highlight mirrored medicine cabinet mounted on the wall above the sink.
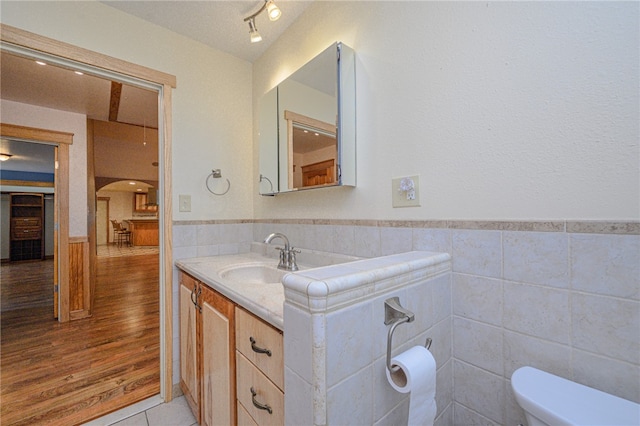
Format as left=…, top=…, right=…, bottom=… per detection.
left=258, top=42, right=356, bottom=195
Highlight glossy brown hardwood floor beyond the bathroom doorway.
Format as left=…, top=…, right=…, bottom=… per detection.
left=0, top=255, right=160, bottom=426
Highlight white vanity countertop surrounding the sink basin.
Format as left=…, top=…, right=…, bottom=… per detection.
left=176, top=253, right=284, bottom=330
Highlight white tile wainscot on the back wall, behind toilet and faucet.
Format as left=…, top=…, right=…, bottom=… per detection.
left=173, top=221, right=640, bottom=425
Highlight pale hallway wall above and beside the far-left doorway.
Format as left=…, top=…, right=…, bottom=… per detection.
left=0, top=100, right=87, bottom=237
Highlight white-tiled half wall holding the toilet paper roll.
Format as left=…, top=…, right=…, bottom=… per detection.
left=284, top=253, right=453, bottom=425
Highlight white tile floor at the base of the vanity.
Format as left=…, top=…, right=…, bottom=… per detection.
left=84, top=396, right=198, bottom=426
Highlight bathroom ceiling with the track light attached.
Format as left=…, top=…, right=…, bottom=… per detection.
left=101, top=0, right=313, bottom=62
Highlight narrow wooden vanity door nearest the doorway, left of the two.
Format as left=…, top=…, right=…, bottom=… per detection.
left=180, top=273, right=200, bottom=423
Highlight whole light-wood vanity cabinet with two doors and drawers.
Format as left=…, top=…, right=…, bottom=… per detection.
left=180, top=271, right=284, bottom=426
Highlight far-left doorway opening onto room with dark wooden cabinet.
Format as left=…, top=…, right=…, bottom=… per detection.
left=0, top=137, right=58, bottom=320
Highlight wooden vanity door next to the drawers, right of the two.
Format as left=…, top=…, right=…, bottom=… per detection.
left=201, top=285, right=236, bottom=426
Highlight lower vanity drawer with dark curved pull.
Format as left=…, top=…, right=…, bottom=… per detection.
left=236, top=352, right=284, bottom=425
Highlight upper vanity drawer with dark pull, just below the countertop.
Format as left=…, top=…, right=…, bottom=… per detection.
left=236, top=307, right=284, bottom=390
